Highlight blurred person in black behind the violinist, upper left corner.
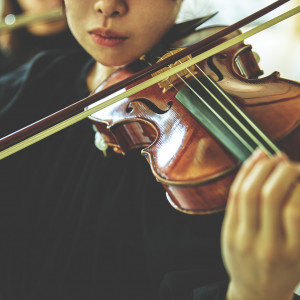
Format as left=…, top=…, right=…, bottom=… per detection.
left=0, top=0, right=79, bottom=74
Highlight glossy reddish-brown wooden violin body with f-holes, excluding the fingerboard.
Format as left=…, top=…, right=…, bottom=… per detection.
left=90, top=27, right=300, bottom=214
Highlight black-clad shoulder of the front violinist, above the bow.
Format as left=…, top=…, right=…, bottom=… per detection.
left=0, top=50, right=92, bottom=134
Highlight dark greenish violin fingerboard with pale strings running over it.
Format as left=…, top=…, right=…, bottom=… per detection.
left=176, top=76, right=279, bottom=162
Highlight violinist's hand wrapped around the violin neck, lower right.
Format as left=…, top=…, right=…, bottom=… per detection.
left=222, top=150, right=300, bottom=300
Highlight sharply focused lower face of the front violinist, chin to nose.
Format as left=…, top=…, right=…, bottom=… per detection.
left=65, top=0, right=182, bottom=67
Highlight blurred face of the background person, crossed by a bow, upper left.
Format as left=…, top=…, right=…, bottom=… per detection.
left=17, top=0, right=67, bottom=35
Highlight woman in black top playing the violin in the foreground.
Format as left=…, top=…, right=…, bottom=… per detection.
left=0, top=0, right=300, bottom=300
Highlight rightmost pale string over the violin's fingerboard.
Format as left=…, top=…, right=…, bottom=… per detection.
left=195, top=64, right=280, bottom=153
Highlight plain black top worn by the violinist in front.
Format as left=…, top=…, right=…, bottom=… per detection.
left=0, top=51, right=227, bottom=300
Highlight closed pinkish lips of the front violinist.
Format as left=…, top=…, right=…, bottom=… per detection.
left=89, top=28, right=128, bottom=47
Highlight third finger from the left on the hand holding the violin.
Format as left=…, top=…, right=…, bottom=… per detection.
left=261, top=160, right=299, bottom=243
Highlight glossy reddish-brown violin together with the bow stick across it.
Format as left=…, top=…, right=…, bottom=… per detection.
left=0, top=1, right=300, bottom=214
